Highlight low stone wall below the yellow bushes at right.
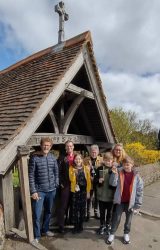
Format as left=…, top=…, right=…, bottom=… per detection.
left=137, top=163, right=160, bottom=186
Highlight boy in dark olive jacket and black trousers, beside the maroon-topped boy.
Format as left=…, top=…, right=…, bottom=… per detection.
left=95, top=152, right=115, bottom=235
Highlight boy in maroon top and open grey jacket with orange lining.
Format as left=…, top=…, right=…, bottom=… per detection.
left=107, top=156, right=143, bottom=244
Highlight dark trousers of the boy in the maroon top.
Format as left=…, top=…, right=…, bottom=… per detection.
left=111, top=203, right=133, bottom=234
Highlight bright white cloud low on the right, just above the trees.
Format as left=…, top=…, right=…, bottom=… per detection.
left=101, top=72, right=160, bottom=128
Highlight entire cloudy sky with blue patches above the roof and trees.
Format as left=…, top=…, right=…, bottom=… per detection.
left=0, top=0, right=160, bottom=129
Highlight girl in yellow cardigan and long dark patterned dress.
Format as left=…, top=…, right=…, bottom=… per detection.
left=69, top=154, right=91, bottom=234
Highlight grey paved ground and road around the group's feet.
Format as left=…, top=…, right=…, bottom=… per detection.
left=4, top=181, right=160, bottom=250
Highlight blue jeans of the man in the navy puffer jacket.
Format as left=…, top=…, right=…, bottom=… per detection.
left=32, top=190, right=56, bottom=239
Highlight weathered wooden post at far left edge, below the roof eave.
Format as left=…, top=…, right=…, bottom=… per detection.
left=0, top=170, right=15, bottom=233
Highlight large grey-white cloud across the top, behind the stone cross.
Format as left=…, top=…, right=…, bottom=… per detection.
left=0, top=0, right=160, bottom=74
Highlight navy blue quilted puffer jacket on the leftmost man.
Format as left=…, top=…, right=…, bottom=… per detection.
left=29, top=153, right=59, bottom=194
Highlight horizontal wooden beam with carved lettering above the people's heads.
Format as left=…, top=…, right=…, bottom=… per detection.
left=27, top=133, right=94, bottom=146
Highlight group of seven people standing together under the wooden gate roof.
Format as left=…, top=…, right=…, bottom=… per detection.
left=29, top=138, right=143, bottom=244
